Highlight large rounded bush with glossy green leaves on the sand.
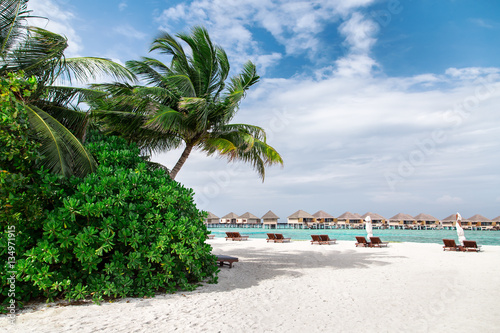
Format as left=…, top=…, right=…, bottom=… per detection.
left=1, top=130, right=217, bottom=308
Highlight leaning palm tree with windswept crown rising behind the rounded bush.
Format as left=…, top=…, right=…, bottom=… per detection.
left=94, top=27, right=283, bottom=180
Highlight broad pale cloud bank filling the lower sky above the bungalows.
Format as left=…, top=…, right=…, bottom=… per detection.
left=152, top=69, right=500, bottom=217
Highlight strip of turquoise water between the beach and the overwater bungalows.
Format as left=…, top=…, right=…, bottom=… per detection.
left=208, top=228, right=500, bottom=245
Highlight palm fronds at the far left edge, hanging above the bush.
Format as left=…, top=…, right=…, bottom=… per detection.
left=0, top=0, right=134, bottom=176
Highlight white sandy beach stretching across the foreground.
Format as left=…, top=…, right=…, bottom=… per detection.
left=0, top=238, right=500, bottom=332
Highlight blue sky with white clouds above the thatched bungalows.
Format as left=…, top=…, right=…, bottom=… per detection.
left=28, top=0, right=500, bottom=222
